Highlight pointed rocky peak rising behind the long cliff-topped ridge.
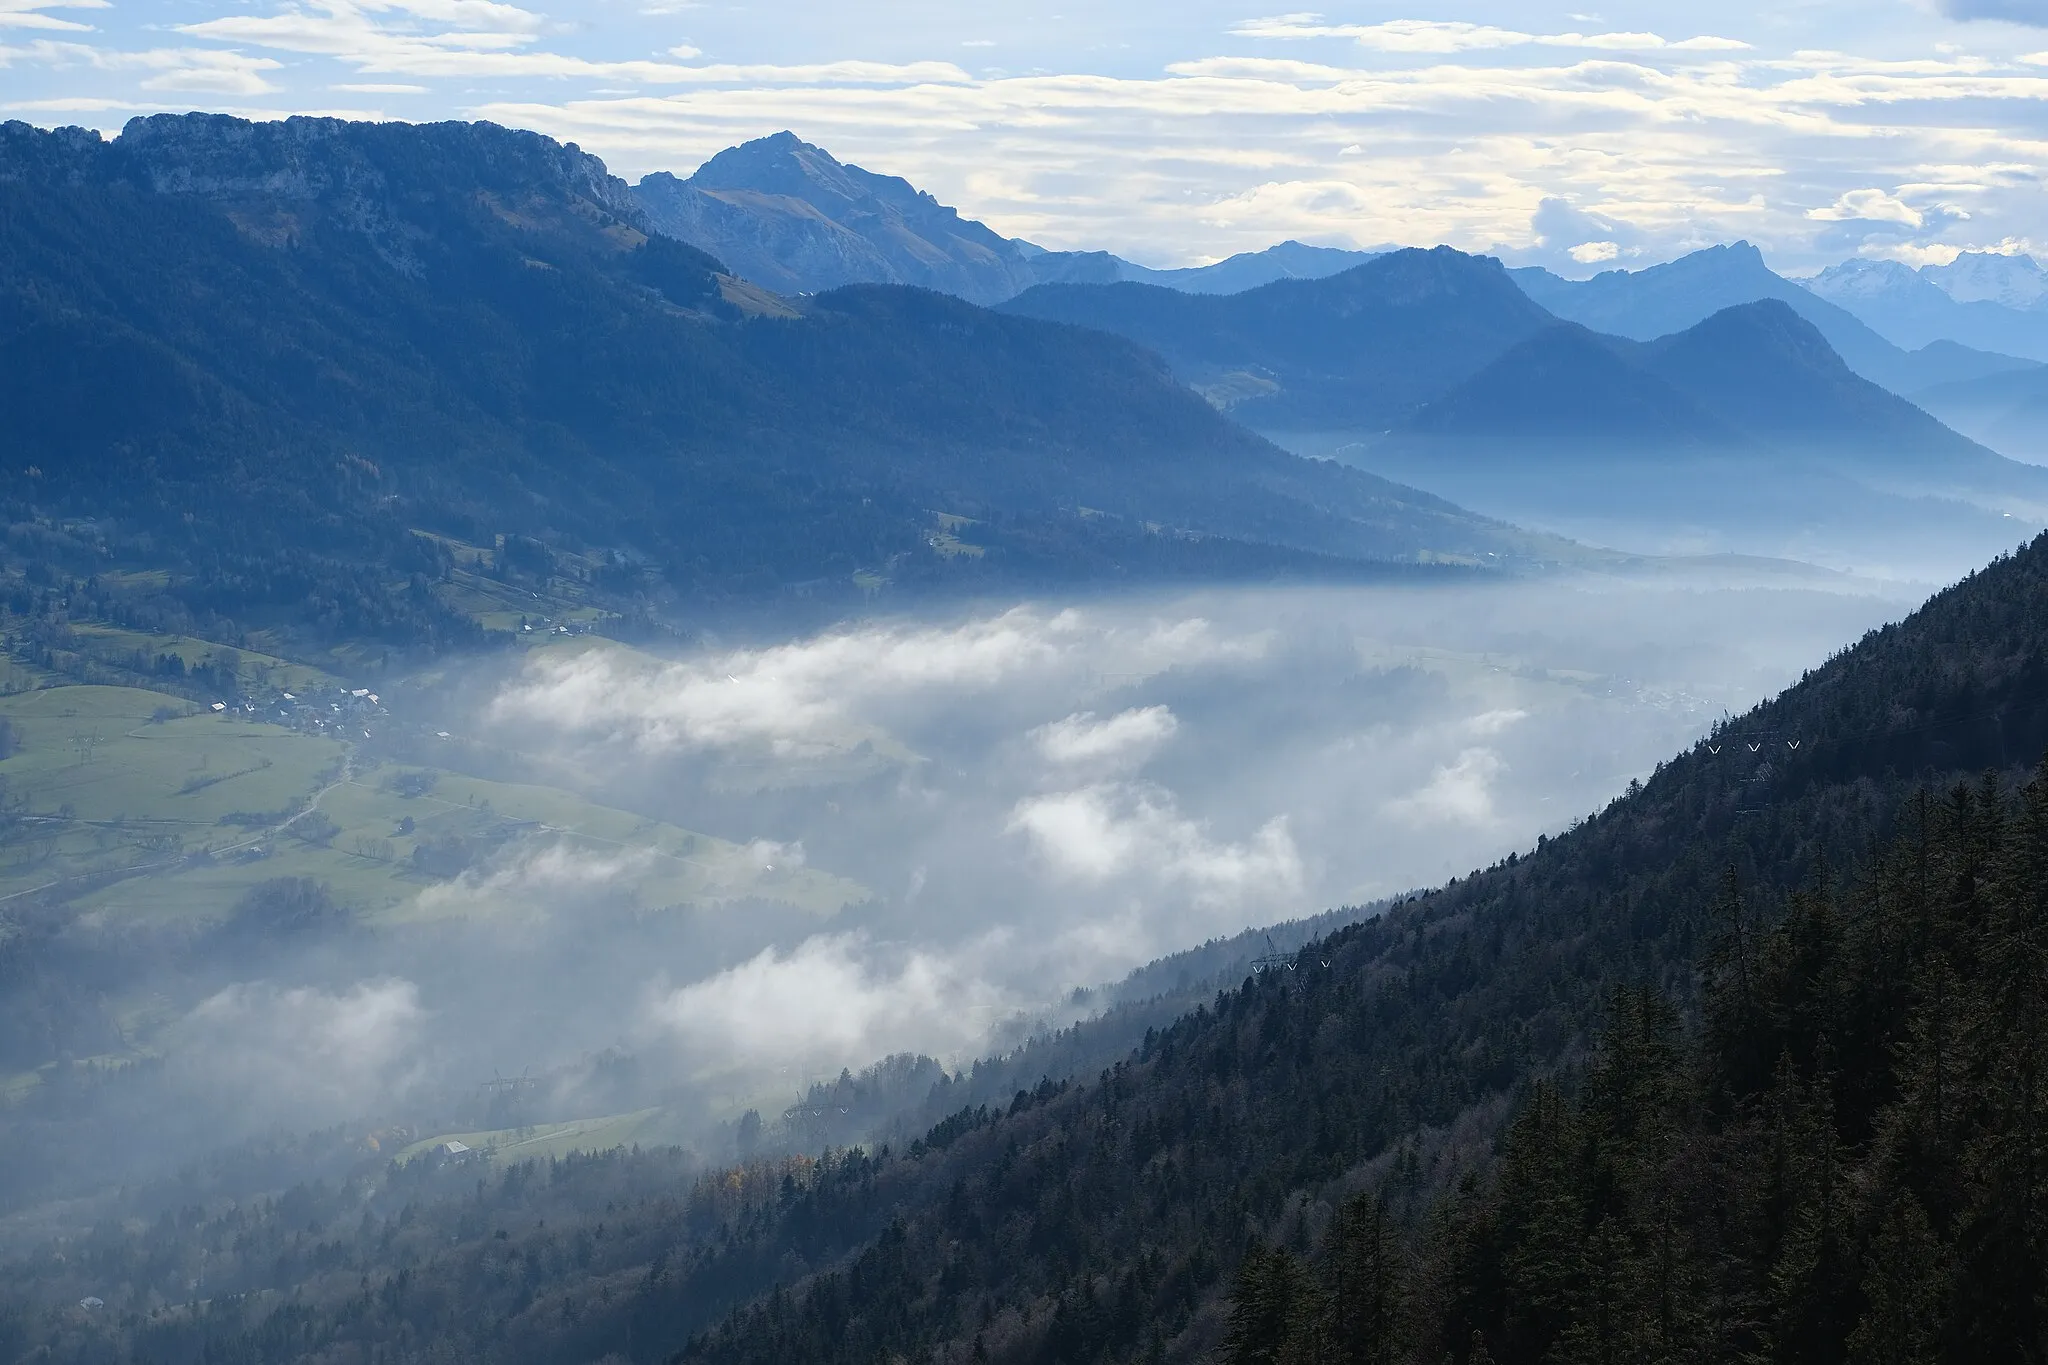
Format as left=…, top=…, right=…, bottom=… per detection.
left=633, top=133, right=1038, bottom=303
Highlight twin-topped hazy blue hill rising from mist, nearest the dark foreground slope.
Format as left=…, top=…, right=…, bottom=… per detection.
left=1346, top=299, right=2048, bottom=575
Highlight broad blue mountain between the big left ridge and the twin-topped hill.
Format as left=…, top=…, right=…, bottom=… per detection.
left=1001, top=248, right=1552, bottom=432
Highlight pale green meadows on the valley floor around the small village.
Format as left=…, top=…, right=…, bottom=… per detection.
left=0, top=686, right=862, bottom=921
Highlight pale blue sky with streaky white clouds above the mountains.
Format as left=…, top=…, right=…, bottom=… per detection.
left=12, top=0, right=2048, bottom=272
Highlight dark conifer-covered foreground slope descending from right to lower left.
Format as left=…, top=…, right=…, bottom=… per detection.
left=16, top=519, right=2048, bottom=1365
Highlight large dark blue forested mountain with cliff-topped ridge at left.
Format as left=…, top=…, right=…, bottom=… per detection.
left=0, top=115, right=1548, bottom=639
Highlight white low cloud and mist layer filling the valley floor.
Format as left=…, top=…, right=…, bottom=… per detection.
left=460, top=583, right=1888, bottom=1083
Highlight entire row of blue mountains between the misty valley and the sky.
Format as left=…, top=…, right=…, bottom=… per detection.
left=16, top=115, right=2048, bottom=593
